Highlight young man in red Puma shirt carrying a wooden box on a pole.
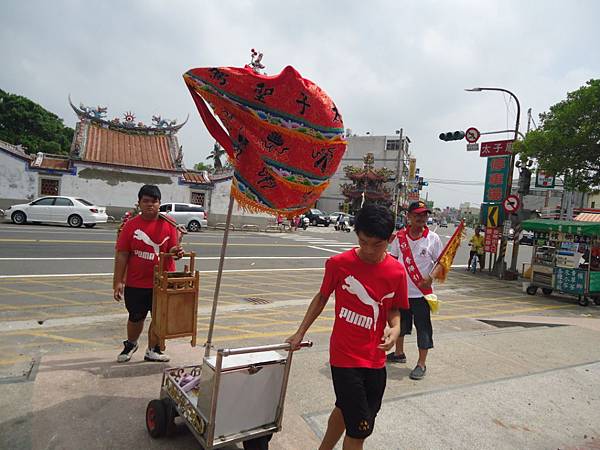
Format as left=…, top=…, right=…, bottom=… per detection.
left=113, top=184, right=183, bottom=362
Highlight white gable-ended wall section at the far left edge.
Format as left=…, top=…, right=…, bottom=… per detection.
left=0, top=151, right=37, bottom=208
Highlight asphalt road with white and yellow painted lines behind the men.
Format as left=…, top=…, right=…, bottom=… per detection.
left=0, top=224, right=552, bottom=377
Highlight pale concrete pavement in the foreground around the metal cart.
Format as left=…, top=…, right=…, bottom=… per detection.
left=0, top=316, right=600, bottom=450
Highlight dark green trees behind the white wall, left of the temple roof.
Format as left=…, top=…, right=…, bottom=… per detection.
left=0, top=89, right=74, bottom=155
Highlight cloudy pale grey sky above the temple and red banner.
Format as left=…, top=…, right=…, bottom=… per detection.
left=0, top=0, right=600, bottom=207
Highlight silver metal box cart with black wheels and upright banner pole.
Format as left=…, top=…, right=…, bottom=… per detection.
left=146, top=197, right=312, bottom=450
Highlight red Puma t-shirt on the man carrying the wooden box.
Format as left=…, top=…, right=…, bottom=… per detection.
left=117, top=215, right=178, bottom=288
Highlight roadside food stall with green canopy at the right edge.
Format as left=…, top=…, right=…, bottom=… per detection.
left=522, top=219, right=600, bottom=306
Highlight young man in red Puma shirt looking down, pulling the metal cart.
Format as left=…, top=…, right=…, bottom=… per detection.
left=286, top=205, right=408, bottom=450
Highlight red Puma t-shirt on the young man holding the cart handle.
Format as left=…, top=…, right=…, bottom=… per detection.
left=320, top=249, right=409, bottom=369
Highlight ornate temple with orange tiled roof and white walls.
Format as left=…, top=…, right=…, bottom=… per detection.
left=0, top=99, right=223, bottom=217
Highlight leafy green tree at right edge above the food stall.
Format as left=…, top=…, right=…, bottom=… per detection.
left=517, top=80, right=600, bottom=192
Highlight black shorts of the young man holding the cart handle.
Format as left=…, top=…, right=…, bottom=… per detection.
left=331, top=366, right=387, bottom=439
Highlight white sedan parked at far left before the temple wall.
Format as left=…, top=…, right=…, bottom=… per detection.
left=5, top=195, right=108, bottom=228
